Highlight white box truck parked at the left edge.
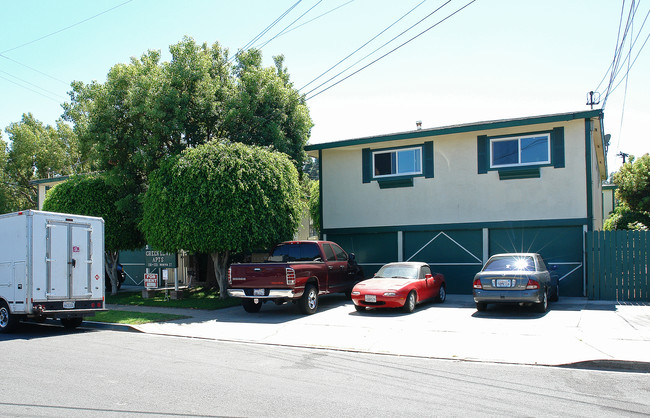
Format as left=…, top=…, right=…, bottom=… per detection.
left=0, top=210, right=105, bottom=332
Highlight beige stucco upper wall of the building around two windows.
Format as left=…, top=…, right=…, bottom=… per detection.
left=321, top=120, right=601, bottom=229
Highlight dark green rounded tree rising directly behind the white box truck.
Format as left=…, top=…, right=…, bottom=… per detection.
left=43, top=175, right=144, bottom=294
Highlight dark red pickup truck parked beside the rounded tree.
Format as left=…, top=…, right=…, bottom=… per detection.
left=228, top=241, right=364, bottom=315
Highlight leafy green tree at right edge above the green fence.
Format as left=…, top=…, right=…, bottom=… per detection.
left=605, top=154, right=650, bottom=230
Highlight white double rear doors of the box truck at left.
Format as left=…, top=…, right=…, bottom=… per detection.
left=46, top=220, right=92, bottom=299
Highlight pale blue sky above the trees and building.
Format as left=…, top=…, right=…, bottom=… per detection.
left=0, top=0, right=650, bottom=171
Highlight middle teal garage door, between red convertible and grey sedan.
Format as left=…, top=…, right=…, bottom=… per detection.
left=403, top=229, right=483, bottom=295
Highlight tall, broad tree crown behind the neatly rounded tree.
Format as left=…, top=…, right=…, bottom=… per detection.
left=64, top=37, right=312, bottom=191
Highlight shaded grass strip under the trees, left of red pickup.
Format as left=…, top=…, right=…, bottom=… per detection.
left=106, top=287, right=241, bottom=310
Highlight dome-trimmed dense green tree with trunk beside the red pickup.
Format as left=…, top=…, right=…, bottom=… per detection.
left=141, top=140, right=304, bottom=298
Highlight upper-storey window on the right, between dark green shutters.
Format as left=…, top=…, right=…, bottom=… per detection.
left=490, top=134, right=551, bottom=168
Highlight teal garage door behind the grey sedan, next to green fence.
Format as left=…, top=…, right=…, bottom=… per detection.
left=489, top=226, right=584, bottom=297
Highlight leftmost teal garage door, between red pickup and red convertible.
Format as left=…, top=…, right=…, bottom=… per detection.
left=327, top=232, right=397, bottom=278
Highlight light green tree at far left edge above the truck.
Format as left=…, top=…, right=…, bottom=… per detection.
left=0, top=113, right=90, bottom=210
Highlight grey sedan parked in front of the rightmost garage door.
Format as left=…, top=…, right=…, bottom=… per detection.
left=473, top=253, right=559, bottom=312
